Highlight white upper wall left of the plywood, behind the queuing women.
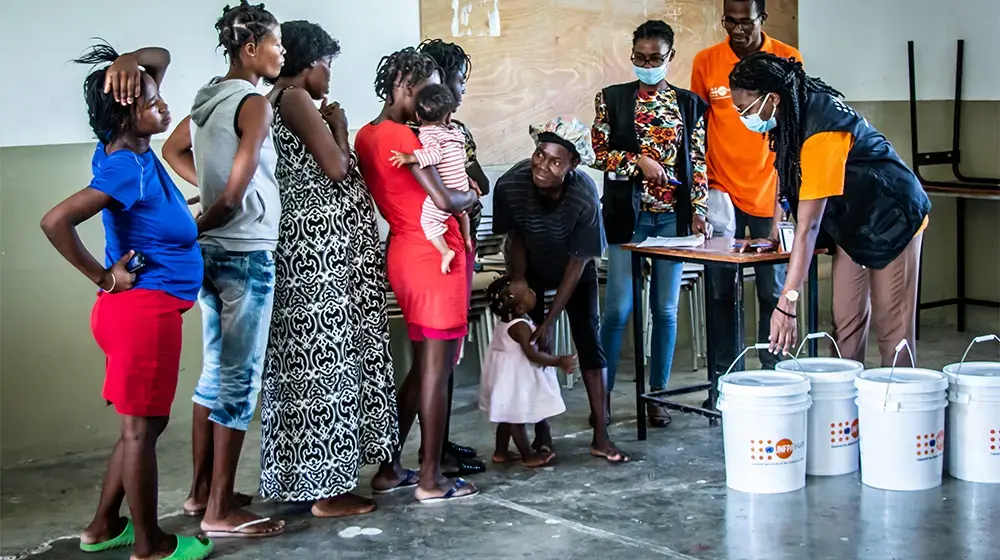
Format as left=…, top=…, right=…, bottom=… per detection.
left=0, top=0, right=420, bottom=147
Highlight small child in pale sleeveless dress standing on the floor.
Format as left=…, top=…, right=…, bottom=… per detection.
left=479, top=276, right=577, bottom=468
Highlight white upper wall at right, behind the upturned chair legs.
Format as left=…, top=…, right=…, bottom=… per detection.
left=799, top=0, right=1000, bottom=101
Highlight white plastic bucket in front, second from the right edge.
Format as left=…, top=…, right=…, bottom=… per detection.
left=854, top=354, right=948, bottom=490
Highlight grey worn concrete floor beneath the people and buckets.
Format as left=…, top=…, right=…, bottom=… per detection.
left=0, top=328, right=1000, bottom=560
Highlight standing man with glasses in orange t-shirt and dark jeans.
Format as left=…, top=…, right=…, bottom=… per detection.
left=691, top=0, right=802, bottom=373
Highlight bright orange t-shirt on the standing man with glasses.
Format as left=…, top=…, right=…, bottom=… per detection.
left=691, top=34, right=802, bottom=218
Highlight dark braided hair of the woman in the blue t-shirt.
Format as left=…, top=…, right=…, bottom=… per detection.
left=73, top=41, right=138, bottom=146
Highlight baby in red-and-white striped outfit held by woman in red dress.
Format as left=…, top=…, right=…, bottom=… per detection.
left=390, top=85, right=472, bottom=274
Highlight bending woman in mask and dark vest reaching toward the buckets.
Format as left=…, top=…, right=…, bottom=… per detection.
left=729, top=53, right=931, bottom=366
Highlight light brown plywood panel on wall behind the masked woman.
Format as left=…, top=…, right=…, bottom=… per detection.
left=420, top=0, right=798, bottom=164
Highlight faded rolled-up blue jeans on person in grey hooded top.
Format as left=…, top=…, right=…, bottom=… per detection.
left=192, top=245, right=274, bottom=431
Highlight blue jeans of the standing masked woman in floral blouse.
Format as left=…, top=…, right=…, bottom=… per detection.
left=601, top=212, right=684, bottom=391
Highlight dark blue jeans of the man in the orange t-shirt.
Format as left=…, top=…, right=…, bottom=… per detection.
left=706, top=208, right=788, bottom=375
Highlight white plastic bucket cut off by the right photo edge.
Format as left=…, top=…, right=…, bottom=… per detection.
left=944, top=335, right=1000, bottom=484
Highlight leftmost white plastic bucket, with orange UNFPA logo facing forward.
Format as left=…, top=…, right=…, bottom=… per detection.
left=717, top=344, right=812, bottom=494
